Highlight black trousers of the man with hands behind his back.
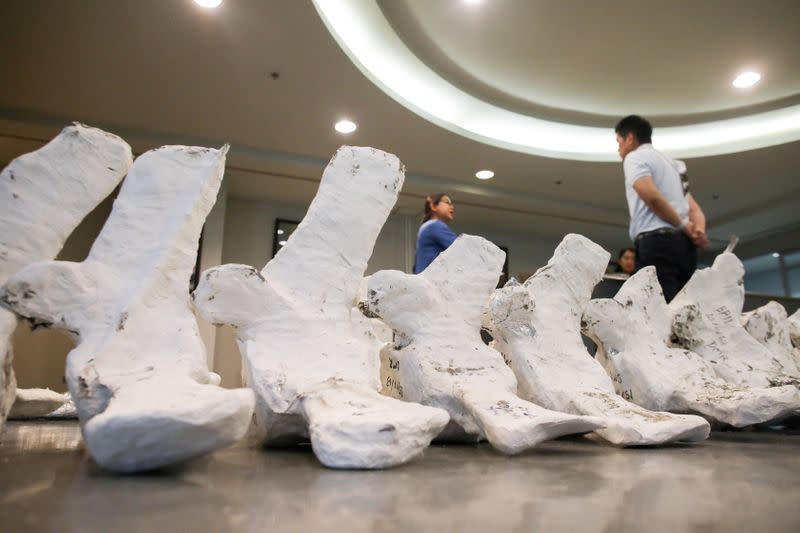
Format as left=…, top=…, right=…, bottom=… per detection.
left=635, top=230, right=697, bottom=302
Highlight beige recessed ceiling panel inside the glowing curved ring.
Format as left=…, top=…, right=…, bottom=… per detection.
left=380, top=0, right=800, bottom=120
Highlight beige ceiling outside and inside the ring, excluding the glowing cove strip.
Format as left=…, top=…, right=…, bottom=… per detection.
left=0, top=0, right=800, bottom=258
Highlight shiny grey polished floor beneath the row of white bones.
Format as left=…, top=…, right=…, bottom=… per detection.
left=0, top=421, right=800, bottom=533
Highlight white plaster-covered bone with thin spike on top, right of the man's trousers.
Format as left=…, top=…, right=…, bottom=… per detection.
left=669, top=252, right=800, bottom=387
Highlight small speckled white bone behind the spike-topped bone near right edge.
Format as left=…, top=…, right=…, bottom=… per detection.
left=740, top=301, right=800, bottom=376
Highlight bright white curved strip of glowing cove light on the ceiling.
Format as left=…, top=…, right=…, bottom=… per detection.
left=313, top=0, right=800, bottom=162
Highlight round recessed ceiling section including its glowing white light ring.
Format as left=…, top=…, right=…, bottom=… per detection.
left=315, top=0, right=800, bottom=161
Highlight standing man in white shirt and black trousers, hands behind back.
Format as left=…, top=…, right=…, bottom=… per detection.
left=614, top=115, right=708, bottom=302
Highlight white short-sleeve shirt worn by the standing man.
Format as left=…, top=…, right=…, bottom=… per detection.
left=622, top=143, right=689, bottom=239
